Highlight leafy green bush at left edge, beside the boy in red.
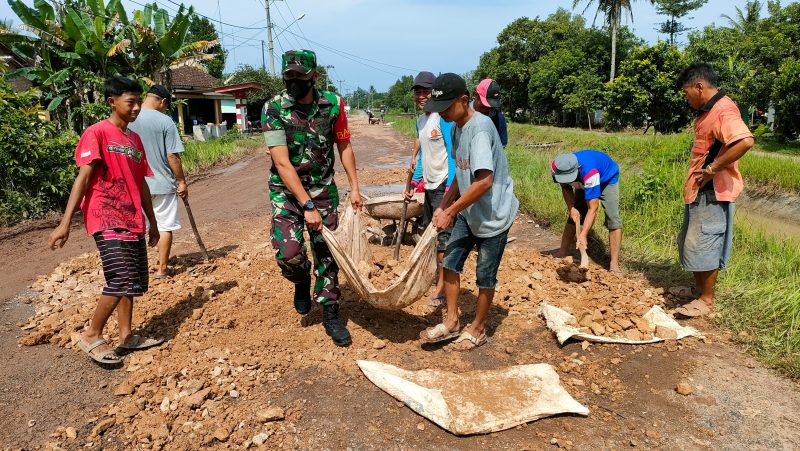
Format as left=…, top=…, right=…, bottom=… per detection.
left=0, top=79, right=77, bottom=226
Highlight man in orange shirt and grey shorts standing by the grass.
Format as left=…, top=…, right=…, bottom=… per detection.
left=676, top=63, right=754, bottom=317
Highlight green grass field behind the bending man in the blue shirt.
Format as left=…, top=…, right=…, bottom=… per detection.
left=390, top=117, right=800, bottom=378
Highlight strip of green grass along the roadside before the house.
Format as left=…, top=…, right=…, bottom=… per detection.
left=181, top=134, right=264, bottom=173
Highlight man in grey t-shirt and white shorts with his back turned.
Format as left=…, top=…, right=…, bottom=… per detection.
left=128, top=85, right=189, bottom=279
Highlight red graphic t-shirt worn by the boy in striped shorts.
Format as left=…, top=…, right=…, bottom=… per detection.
left=75, top=119, right=153, bottom=235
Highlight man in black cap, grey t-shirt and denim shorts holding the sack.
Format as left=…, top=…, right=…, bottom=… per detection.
left=420, top=73, right=519, bottom=351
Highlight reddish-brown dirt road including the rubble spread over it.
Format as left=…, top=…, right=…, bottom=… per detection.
left=0, top=118, right=800, bottom=449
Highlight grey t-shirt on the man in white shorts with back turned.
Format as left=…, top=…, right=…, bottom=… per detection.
left=128, top=108, right=183, bottom=194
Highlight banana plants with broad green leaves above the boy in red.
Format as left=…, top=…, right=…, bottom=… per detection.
left=0, top=0, right=217, bottom=131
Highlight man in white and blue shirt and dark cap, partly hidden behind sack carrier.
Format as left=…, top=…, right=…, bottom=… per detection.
left=405, top=72, right=456, bottom=307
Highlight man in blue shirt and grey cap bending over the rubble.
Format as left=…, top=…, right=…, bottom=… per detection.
left=550, top=150, right=622, bottom=272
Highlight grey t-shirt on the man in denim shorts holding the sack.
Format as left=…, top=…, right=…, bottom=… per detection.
left=453, top=111, right=519, bottom=238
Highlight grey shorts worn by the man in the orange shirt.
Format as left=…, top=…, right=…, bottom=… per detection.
left=678, top=191, right=736, bottom=272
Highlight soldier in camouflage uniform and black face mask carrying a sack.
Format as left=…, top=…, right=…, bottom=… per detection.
left=261, top=50, right=361, bottom=346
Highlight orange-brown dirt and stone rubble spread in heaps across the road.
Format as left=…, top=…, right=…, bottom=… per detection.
left=14, top=224, right=682, bottom=449
